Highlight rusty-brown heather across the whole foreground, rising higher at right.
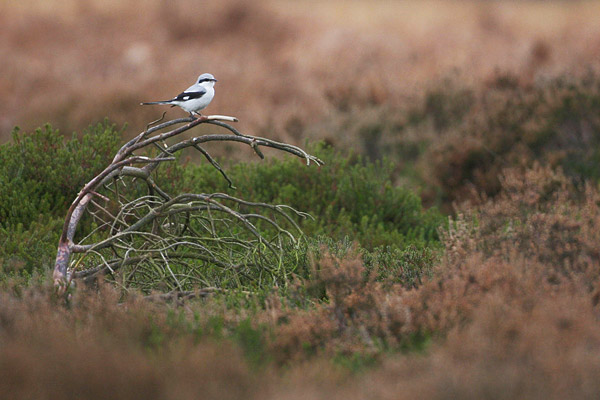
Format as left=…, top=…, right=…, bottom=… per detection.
left=0, top=167, right=600, bottom=399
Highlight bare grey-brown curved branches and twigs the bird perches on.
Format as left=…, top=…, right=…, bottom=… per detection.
left=53, top=114, right=323, bottom=291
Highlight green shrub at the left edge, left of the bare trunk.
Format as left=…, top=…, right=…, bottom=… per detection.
left=0, top=121, right=121, bottom=271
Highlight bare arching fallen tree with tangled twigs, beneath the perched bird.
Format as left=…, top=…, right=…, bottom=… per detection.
left=53, top=114, right=322, bottom=296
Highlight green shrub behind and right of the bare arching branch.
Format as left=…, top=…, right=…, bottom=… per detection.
left=178, top=145, right=443, bottom=249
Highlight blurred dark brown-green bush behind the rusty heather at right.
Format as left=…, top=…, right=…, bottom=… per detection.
left=312, top=73, right=600, bottom=213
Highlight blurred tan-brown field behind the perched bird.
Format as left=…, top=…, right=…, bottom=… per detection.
left=0, top=0, right=600, bottom=142
